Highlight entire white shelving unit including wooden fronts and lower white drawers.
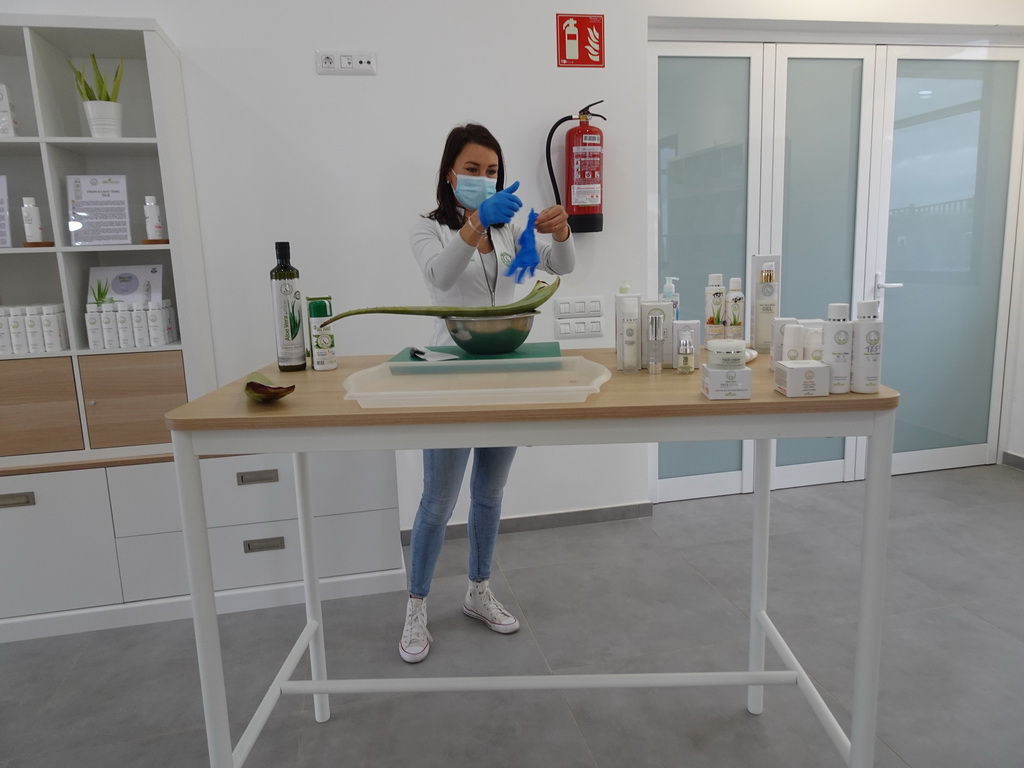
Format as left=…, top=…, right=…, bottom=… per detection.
left=0, top=14, right=406, bottom=642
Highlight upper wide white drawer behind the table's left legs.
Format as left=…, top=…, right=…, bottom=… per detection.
left=118, top=509, right=402, bottom=601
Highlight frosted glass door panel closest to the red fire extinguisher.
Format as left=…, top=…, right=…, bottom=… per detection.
left=645, top=44, right=762, bottom=498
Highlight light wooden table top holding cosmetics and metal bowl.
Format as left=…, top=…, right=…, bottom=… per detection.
left=166, top=348, right=899, bottom=431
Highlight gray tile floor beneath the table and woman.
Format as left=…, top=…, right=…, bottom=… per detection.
left=0, top=466, right=1024, bottom=768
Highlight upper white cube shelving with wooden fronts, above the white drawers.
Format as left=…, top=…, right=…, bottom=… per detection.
left=0, top=14, right=215, bottom=469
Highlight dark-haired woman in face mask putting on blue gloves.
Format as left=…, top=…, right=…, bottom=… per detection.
left=398, top=124, right=575, bottom=664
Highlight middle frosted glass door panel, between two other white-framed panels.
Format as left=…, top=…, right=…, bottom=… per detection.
left=770, top=45, right=874, bottom=486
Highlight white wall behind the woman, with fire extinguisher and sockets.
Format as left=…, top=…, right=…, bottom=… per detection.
left=4, top=0, right=1024, bottom=522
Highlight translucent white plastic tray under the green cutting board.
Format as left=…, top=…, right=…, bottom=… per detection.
left=344, top=356, right=611, bottom=408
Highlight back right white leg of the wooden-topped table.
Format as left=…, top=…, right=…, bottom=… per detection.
left=746, top=438, right=771, bottom=715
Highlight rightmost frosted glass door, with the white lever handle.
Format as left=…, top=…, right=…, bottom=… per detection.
left=871, top=49, right=1022, bottom=472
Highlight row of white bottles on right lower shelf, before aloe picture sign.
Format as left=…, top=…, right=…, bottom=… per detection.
left=85, top=299, right=179, bottom=349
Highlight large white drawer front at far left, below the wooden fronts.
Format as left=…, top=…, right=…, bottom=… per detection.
left=0, top=469, right=121, bottom=617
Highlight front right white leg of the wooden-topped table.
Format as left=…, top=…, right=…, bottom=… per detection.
left=850, top=411, right=896, bottom=768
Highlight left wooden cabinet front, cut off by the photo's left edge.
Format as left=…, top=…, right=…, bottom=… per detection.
left=0, top=357, right=85, bottom=456
